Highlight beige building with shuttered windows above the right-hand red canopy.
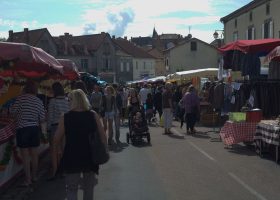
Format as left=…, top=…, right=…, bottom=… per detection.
left=221, top=0, right=280, bottom=43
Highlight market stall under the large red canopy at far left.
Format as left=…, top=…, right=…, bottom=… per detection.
left=0, top=42, right=63, bottom=188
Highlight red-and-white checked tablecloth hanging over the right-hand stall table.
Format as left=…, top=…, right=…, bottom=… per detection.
left=220, top=121, right=258, bottom=145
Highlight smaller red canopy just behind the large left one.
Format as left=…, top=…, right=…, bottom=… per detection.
left=57, top=59, right=79, bottom=80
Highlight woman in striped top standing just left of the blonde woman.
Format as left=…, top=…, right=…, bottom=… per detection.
left=47, top=82, right=70, bottom=180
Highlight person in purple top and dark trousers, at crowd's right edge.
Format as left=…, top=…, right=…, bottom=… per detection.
left=182, top=85, right=200, bottom=134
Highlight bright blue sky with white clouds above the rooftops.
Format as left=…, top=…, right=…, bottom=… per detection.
left=0, top=0, right=252, bottom=43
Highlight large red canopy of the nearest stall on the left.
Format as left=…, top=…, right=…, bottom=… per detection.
left=0, top=42, right=63, bottom=78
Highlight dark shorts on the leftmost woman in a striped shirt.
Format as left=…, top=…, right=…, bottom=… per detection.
left=16, top=126, right=40, bottom=148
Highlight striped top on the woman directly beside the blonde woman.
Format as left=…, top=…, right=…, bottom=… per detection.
left=47, top=96, right=70, bottom=129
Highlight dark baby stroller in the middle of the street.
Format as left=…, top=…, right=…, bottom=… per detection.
left=126, top=106, right=151, bottom=144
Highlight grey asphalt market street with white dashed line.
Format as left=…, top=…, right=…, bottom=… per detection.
left=0, top=122, right=280, bottom=200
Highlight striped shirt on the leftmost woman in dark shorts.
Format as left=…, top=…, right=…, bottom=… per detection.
left=12, top=94, right=45, bottom=129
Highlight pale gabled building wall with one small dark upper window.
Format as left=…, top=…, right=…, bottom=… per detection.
left=164, top=38, right=220, bottom=74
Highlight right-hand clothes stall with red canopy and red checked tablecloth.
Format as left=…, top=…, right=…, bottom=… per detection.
left=217, top=39, right=280, bottom=148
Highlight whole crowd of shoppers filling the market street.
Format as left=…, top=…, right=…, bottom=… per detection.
left=9, top=81, right=199, bottom=199
